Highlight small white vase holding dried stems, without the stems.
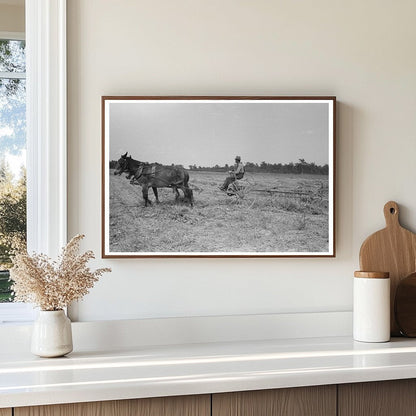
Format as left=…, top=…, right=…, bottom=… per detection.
left=31, top=310, right=72, bottom=358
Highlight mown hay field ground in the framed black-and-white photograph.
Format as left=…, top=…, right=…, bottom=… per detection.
left=109, top=170, right=328, bottom=253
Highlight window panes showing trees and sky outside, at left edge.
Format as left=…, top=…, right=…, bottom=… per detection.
left=0, top=35, right=26, bottom=303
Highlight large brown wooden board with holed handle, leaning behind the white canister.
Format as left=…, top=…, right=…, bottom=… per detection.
left=360, top=201, right=416, bottom=336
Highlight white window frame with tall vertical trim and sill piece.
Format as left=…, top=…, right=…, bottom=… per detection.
left=0, top=0, right=67, bottom=324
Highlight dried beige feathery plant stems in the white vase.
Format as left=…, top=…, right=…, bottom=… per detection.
left=10, top=234, right=111, bottom=311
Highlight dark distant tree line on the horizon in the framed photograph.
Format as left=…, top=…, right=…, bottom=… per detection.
left=110, top=159, right=329, bottom=175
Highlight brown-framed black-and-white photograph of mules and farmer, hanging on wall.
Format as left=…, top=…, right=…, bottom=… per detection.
left=102, top=96, right=336, bottom=258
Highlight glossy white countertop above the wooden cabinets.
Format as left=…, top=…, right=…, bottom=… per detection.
left=0, top=337, right=416, bottom=408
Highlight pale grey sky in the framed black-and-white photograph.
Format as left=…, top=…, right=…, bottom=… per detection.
left=109, top=101, right=329, bottom=168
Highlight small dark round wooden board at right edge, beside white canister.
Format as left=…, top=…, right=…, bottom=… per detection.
left=394, top=273, right=416, bottom=337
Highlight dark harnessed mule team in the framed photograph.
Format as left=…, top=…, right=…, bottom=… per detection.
left=114, top=153, right=193, bottom=206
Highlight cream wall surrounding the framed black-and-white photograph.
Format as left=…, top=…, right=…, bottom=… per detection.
left=68, top=0, right=416, bottom=321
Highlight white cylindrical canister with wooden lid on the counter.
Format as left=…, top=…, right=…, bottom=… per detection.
left=353, top=271, right=390, bottom=342
